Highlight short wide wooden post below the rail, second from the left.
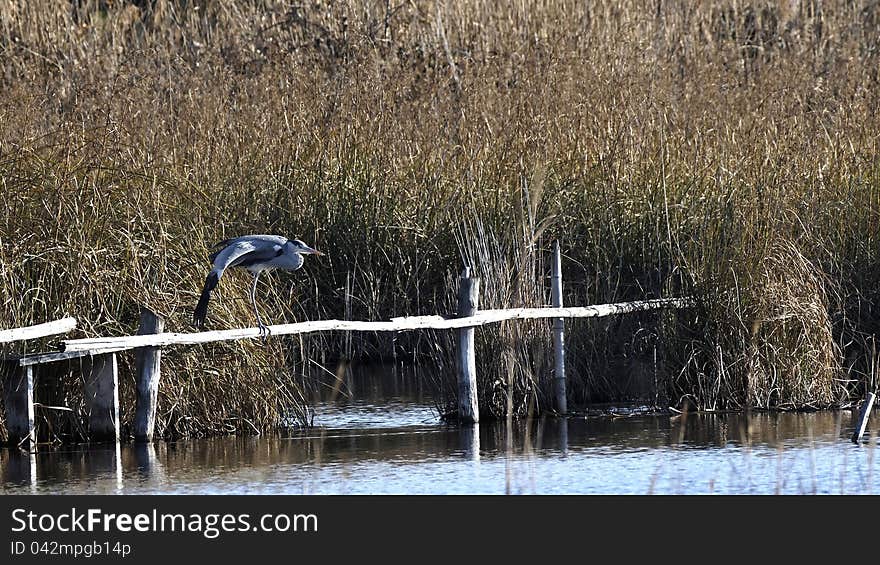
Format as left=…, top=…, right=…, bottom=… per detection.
left=83, top=353, right=119, bottom=441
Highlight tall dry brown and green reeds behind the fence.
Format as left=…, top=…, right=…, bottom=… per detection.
left=0, top=0, right=880, bottom=435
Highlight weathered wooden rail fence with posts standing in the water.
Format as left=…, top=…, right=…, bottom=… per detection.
left=0, top=243, right=693, bottom=444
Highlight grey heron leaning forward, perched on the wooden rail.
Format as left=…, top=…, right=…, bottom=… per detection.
left=193, top=235, right=323, bottom=339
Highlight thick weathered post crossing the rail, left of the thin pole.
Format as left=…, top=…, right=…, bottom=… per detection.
left=458, top=267, right=480, bottom=424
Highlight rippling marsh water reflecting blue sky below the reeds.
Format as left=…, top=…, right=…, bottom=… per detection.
left=0, top=366, right=880, bottom=494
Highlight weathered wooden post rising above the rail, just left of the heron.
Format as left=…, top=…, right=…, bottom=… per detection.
left=134, top=308, right=165, bottom=441
